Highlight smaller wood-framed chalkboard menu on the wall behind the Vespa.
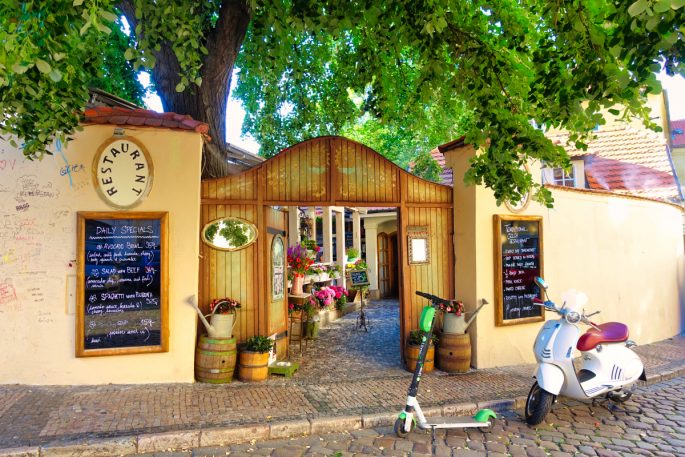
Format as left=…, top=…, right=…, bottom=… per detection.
left=494, top=215, right=545, bottom=326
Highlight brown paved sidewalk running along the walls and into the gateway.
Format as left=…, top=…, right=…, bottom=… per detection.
left=0, top=301, right=685, bottom=448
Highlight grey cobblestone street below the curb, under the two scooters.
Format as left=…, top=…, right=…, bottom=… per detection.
left=168, top=377, right=685, bottom=457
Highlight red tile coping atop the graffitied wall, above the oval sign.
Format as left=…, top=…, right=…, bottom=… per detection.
left=84, top=106, right=209, bottom=136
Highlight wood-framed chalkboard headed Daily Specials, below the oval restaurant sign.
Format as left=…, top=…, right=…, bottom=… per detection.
left=76, top=212, right=169, bottom=357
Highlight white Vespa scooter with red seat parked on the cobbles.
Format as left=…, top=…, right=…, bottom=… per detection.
left=526, top=277, right=646, bottom=425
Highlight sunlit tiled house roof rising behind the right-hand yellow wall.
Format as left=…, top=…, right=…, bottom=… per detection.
left=550, top=126, right=680, bottom=200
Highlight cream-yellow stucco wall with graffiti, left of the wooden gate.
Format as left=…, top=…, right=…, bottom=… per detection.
left=0, top=125, right=202, bottom=384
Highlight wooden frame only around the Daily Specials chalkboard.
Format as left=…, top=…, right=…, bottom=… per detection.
left=76, top=211, right=169, bottom=357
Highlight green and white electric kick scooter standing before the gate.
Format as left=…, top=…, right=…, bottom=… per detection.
left=395, top=291, right=497, bottom=438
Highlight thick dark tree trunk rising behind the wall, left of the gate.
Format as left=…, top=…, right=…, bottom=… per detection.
left=119, top=0, right=252, bottom=178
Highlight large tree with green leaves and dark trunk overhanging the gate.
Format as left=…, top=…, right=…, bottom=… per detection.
left=0, top=0, right=685, bottom=203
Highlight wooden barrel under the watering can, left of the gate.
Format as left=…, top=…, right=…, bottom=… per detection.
left=195, top=335, right=237, bottom=384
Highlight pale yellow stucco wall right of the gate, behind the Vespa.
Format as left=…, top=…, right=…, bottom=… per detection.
left=445, top=148, right=685, bottom=368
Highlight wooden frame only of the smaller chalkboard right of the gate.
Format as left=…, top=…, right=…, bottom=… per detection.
left=493, top=214, right=545, bottom=327
